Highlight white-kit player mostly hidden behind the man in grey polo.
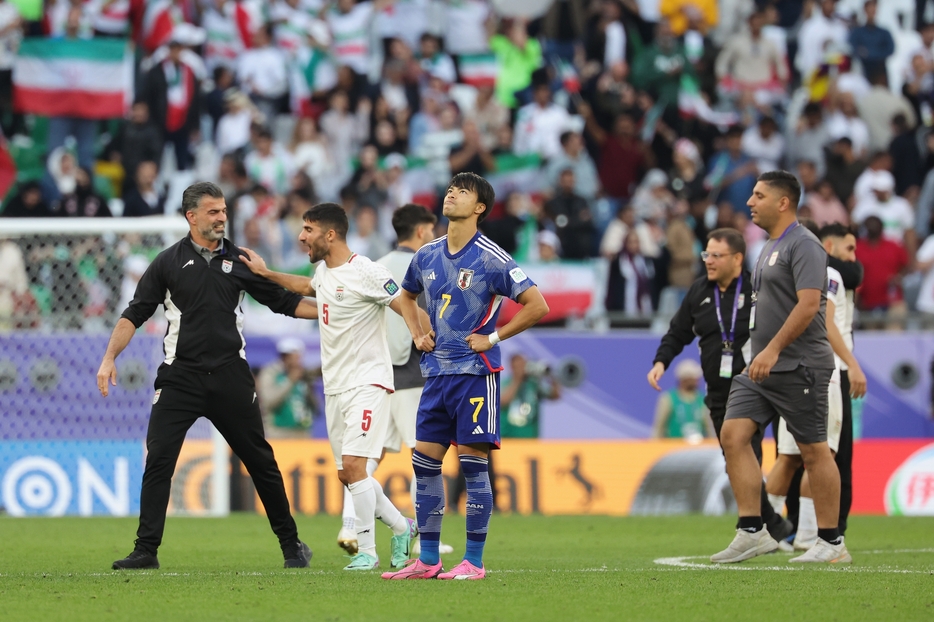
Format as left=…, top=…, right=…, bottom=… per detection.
left=766, top=223, right=866, bottom=551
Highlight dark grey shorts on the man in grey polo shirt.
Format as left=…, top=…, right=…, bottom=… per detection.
left=725, top=365, right=833, bottom=444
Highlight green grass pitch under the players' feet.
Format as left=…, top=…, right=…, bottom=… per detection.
left=0, top=515, right=934, bottom=622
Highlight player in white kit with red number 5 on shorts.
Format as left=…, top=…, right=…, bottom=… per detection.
left=241, top=203, right=418, bottom=570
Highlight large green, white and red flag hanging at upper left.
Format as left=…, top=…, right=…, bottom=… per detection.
left=13, top=38, right=133, bottom=119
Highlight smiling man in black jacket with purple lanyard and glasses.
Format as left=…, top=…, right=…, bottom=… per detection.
left=648, top=229, right=792, bottom=540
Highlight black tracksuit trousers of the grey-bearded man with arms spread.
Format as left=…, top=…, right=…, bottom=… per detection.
left=136, top=359, right=298, bottom=554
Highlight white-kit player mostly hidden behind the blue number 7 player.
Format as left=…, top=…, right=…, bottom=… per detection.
left=337, top=203, right=454, bottom=555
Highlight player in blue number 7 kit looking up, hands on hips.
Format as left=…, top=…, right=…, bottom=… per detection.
left=383, top=173, right=548, bottom=579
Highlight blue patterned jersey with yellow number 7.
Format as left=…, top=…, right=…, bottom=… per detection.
left=402, top=232, right=535, bottom=377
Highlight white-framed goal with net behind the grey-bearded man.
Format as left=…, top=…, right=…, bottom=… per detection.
left=0, top=216, right=230, bottom=516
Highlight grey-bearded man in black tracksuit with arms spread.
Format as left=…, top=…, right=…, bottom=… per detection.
left=97, top=182, right=318, bottom=570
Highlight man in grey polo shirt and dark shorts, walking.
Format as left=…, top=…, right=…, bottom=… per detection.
left=710, top=171, right=852, bottom=563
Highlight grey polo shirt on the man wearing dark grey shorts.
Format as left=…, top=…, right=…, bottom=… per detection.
left=749, top=225, right=834, bottom=372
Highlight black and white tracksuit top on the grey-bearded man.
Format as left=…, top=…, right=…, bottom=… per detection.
left=122, top=234, right=302, bottom=373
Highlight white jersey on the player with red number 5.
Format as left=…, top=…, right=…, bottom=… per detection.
left=311, top=253, right=400, bottom=395
